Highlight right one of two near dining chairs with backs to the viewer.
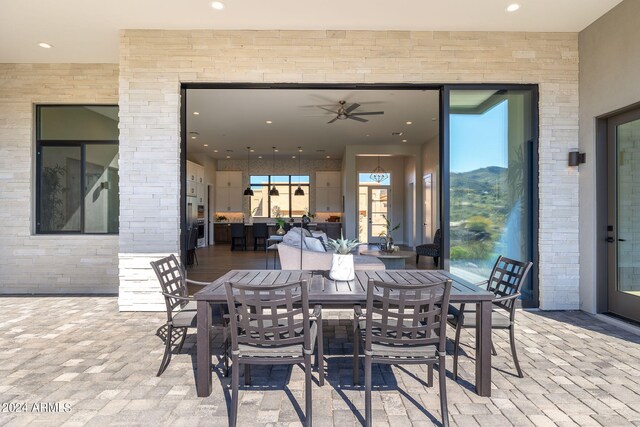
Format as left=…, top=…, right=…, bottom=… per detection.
left=353, top=279, right=451, bottom=426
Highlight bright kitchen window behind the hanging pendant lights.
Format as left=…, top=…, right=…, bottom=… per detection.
left=250, top=175, right=309, bottom=218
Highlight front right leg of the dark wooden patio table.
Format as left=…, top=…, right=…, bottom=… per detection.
left=476, top=301, right=492, bottom=397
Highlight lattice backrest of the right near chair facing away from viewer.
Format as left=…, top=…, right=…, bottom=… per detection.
left=365, top=280, right=451, bottom=352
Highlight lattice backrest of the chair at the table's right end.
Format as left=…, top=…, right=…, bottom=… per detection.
left=487, top=256, right=533, bottom=313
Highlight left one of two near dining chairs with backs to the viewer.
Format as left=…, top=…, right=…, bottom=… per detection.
left=225, top=280, right=324, bottom=426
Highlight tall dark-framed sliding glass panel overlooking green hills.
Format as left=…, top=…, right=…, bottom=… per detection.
left=443, top=86, right=537, bottom=306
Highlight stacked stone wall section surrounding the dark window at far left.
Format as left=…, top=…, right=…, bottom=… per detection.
left=0, top=64, right=118, bottom=294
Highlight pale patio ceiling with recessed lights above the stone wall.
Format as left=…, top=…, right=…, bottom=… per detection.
left=0, top=0, right=621, bottom=63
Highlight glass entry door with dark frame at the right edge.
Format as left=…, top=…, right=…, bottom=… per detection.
left=607, top=111, right=640, bottom=321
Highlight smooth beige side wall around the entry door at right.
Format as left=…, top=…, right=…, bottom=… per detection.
left=579, top=0, right=640, bottom=312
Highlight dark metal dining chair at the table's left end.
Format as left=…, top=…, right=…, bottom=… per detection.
left=151, top=254, right=229, bottom=377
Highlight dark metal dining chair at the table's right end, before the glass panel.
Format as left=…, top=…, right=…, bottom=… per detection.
left=449, top=256, right=533, bottom=380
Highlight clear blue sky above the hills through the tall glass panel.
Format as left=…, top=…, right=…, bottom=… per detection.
left=450, top=101, right=509, bottom=172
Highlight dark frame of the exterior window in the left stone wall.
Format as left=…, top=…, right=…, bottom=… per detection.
left=33, top=104, right=120, bottom=236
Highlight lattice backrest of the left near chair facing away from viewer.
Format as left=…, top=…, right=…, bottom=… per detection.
left=225, top=280, right=311, bottom=351
